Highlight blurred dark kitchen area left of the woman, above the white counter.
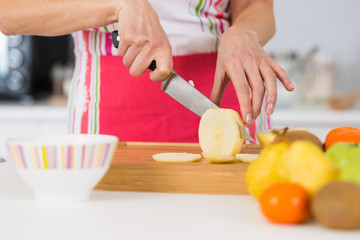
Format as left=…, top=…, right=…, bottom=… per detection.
left=0, top=33, right=74, bottom=104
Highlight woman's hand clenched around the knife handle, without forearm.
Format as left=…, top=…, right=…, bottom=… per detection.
left=118, top=0, right=173, bottom=82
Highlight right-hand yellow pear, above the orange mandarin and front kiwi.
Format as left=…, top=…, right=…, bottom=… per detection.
left=283, top=140, right=338, bottom=195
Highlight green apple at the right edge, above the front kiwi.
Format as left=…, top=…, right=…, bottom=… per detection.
left=326, top=142, right=360, bottom=170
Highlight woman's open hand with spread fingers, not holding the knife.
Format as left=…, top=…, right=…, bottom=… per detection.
left=210, top=26, right=294, bottom=127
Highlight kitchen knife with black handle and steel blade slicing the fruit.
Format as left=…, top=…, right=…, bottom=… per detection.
left=112, top=31, right=254, bottom=141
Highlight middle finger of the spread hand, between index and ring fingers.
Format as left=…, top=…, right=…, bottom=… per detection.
left=244, top=62, right=265, bottom=119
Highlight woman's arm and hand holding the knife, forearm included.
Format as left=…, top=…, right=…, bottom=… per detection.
left=0, top=0, right=173, bottom=81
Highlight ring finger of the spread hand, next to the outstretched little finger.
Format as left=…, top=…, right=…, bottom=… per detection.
left=260, top=62, right=277, bottom=114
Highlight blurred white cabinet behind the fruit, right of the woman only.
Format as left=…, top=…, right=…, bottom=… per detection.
left=271, top=109, right=360, bottom=141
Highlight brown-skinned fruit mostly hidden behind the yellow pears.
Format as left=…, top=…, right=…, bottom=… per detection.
left=272, top=129, right=324, bottom=150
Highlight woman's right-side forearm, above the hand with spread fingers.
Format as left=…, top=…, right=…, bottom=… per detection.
left=230, top=0, right=275, bottom=46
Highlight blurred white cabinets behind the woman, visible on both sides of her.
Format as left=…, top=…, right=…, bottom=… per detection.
left=0, top=104, right=360, bottom=156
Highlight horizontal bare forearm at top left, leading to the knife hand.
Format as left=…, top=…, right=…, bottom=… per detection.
left=0, top=0, right=122, bottom=36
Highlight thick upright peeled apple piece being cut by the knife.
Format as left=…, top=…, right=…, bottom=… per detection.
left=199, top=108, right=243, bottom=156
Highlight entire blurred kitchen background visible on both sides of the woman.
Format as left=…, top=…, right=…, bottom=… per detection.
left=0, top=0, right=360, bottom=154
